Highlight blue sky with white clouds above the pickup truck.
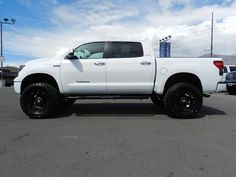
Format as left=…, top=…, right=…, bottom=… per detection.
left=0, top=0, right=236, bottom=66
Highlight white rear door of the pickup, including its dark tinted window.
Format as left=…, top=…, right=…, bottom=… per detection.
left=106, top=42, right=155, bottom=94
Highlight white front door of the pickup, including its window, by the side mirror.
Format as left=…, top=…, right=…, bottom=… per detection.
left=61, top=42, right=107, bottom=94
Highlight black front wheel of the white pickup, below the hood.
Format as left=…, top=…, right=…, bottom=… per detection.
left=20, top=83, right=59, bottom=119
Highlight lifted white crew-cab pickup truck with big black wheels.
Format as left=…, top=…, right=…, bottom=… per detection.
left=14, top=41, right=224, bottom=118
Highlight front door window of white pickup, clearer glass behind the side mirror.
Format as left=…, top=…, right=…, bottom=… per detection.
left=74, top=42, right=105, bottom=59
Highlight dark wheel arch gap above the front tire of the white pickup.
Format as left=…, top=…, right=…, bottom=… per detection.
left=21, top=73, right=59, bottom=93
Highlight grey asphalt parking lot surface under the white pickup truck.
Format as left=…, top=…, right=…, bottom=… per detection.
left=0, top=88, right=236, bottom=177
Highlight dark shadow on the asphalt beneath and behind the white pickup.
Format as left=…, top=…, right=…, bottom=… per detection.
left=52, top=103, right=226, bottom=119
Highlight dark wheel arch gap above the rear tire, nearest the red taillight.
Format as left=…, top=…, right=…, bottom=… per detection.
left=163, top=72, right=203, bottom=94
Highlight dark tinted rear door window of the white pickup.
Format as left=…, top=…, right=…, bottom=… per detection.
left=111, top=42, right=143, bottom=58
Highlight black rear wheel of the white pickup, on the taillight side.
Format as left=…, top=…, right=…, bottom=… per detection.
left=164, top=83, right=203, bottom=119
